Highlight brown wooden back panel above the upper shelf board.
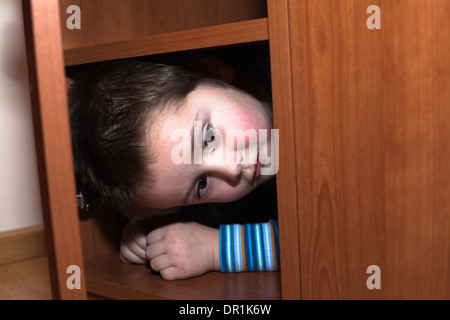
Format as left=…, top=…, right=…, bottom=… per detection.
left=60, top=0, right=267, bottom=49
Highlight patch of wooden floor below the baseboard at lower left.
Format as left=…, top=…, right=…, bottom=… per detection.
left=0, top=256, right=52, bottom=300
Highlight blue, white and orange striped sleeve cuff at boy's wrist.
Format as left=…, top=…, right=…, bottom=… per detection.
left=220, top=220, right=280, bottom=273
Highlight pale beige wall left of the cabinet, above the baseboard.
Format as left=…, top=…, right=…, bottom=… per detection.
left=0, top=0, right=42, bottom=232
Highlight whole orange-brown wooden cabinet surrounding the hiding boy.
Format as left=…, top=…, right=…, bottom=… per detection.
left=23, top=0, right=450, bottom=299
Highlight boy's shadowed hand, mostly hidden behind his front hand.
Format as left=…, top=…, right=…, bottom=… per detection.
left=120, top=222, right=147, bottom=264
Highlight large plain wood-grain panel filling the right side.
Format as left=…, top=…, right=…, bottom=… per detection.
left=289, top=0, right=450, bottom=299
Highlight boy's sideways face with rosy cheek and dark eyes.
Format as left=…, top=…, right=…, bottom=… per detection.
left=143, top=86, right=276, bottom=209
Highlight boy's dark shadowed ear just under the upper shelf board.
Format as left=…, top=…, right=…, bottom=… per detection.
left=187, top=52, right=234, bottom=83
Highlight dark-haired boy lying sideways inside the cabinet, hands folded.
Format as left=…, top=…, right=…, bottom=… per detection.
left=69, top=61, right=278, bottom=280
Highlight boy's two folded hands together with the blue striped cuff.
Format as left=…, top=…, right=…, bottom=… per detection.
left=121, top=220, right=279, bottom=280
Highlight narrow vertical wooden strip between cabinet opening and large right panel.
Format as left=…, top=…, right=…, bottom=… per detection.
left=268, top=0, right=301, bottom=299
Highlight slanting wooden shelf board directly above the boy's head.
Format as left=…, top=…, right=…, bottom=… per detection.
left=64, top=18, right=269, bottom=66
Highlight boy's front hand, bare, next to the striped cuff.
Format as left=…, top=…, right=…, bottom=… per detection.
left=146, top=222, right=220, bottom=280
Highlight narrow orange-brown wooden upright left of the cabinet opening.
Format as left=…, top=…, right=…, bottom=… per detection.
left=23, top=0, right=86, bottom=299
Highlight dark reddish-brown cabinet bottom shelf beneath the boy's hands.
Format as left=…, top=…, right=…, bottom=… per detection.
left=85, top=254, right=281, bottom=300
